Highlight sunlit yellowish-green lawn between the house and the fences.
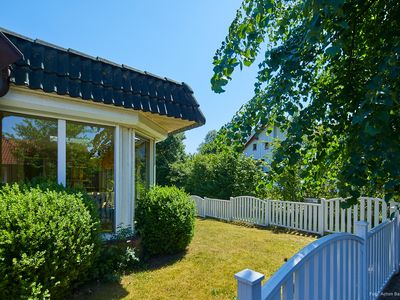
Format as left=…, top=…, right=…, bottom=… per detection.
left=75, top=219, right=315, bottom=300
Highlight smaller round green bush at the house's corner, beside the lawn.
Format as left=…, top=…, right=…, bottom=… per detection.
left=136, top=186, right=195, bottom=256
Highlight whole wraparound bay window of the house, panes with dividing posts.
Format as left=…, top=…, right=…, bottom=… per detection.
left=0, top=111, right=154, bottom=232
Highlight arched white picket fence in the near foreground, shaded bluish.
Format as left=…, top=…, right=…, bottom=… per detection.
left=235, top=212, right=400, bottom=300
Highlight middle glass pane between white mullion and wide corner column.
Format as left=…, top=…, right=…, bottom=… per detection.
left=66, top=121, right=115, bottom=232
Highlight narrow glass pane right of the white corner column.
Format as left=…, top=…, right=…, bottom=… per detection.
left=134, top=135, right=150, bottom=199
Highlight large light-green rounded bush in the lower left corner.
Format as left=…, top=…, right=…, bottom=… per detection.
left=0, top=184, right=98, bottom=299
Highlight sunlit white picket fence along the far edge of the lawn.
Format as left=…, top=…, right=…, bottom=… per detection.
left=191, top=196, right=396, bottom=235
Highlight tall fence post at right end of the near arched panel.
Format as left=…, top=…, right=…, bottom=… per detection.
left=355, top=221, right=370, bottom=299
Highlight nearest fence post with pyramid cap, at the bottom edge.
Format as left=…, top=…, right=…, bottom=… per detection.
left=235, top=269, right=265, bottom=300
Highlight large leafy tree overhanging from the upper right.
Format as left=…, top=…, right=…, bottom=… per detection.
left=211, top=0, right=400, bottom=204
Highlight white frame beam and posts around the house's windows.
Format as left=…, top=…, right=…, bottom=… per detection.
left=0, top=86, right=162, bottom=230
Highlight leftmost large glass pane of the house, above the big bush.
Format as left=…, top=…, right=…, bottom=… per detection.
left=0, top=112, right=57, bottom=183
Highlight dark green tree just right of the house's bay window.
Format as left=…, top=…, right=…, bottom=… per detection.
left=156, top=133, right=186, bottom=185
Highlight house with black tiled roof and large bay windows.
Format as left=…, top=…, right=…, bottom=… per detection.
left=0, top=29, right=205, bottom=232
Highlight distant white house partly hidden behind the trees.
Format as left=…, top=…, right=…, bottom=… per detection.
left=243, top=126, right=285, bottom=171
